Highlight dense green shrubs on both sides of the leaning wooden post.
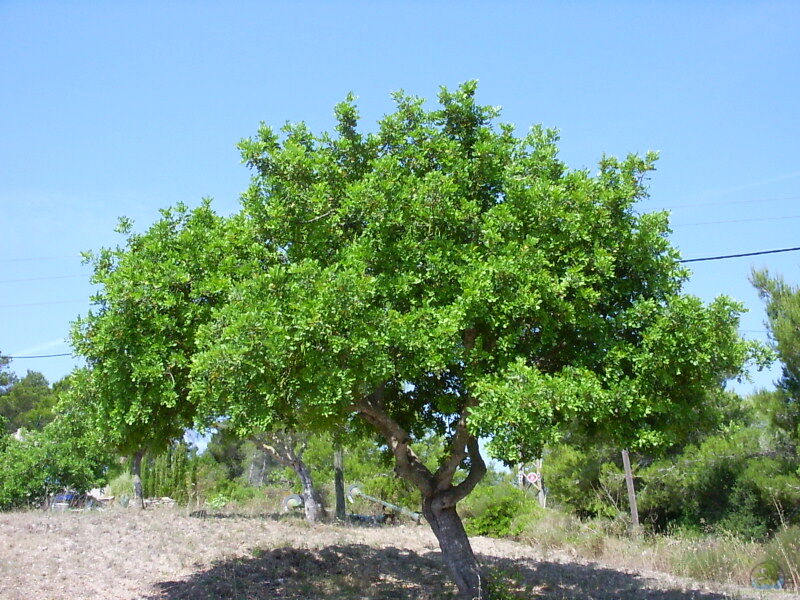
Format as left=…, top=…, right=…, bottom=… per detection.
left=544, top=391, right=800, bottom=539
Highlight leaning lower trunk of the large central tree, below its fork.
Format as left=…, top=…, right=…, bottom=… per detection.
left=422, top=496, right=489, bottom=600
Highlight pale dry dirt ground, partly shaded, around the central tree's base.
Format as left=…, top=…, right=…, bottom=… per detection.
left=0, top=508, right=800, bottom=600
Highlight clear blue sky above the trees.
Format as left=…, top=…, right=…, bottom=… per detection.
left=0, top=0, right=800, bottom=389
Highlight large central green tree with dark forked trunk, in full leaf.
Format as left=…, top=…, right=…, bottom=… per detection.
left=184, top=83, right=760, bottom=598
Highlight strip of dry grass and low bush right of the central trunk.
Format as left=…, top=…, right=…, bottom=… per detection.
left=459, top=485, right=800, bottom=589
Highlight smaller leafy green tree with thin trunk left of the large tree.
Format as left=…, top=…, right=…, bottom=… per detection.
left=72, top=201, right=257, bottom=506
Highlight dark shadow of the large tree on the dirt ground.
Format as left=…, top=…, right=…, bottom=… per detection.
left=146, top=544, right=744, bottom=600
